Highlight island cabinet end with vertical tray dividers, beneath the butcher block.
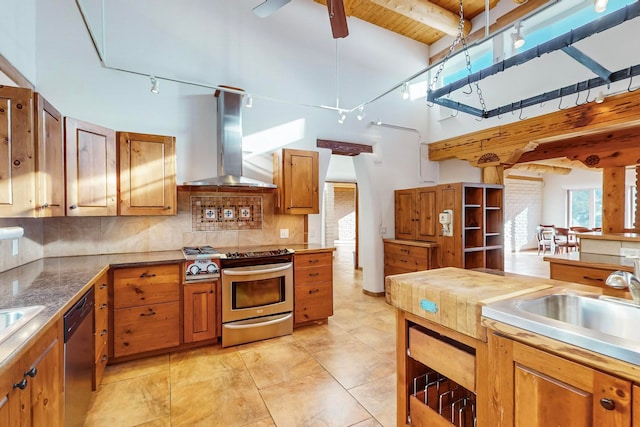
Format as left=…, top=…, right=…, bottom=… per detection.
left=396, top=310, right=489, bottom=427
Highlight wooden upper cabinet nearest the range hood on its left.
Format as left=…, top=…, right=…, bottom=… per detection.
left=117, top=132, right=177, bottom=215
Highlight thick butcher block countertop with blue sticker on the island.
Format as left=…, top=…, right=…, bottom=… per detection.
left=385, top=267, right=553, bottom=342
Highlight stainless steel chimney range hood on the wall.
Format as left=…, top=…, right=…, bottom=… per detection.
left=184, top=88, right=277, bottom=188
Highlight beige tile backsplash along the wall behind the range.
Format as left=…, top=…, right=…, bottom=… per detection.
left=0, top=191, right=304, bottom=272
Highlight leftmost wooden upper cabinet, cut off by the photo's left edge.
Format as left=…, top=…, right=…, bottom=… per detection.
left=0, top=86, right=36, bottom=217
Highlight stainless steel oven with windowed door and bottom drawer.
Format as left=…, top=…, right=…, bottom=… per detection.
left=221, top=249, right=293, bottom=347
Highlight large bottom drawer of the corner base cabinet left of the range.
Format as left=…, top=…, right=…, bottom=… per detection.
left=113, top=301, right=180, bottom=357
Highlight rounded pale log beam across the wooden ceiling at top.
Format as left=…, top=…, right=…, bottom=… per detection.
left=364, top=0, right=471, bottom=37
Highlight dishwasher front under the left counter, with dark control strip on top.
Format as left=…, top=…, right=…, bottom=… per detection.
left=64, top=288, right=94, bottom=427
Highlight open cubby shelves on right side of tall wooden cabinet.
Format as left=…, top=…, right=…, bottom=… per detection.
left=462, top=184, right=504, bottom=270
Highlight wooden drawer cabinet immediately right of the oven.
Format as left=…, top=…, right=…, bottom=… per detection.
left=293, top=252, right=333, bottom=325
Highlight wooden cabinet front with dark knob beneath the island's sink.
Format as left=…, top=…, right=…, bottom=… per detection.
left=488, top=334, right=637, bottom=427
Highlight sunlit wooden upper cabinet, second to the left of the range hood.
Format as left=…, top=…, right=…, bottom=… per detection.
left=64, top=117, right=117, bottom=216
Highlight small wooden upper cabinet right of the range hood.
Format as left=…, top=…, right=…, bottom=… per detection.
left=273, top=148, right=320, bottom=214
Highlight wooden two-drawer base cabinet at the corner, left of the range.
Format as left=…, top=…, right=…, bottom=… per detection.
left=111, top=264, right=181, bottom=358
